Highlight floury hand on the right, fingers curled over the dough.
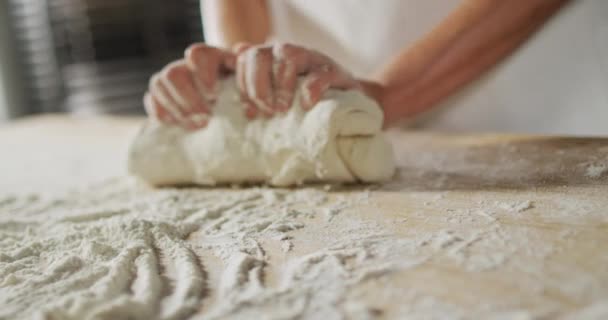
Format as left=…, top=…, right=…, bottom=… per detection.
left=233, top=44, right=361, bottom=118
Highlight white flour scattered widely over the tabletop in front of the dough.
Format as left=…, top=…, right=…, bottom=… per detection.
left=0, top=178, right=608, bottom=320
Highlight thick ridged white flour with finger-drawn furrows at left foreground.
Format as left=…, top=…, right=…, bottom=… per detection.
left=0, top=180, right=388, bottom=319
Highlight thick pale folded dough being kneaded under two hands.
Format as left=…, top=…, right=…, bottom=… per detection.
left=129, top=78, right=395, bottom=186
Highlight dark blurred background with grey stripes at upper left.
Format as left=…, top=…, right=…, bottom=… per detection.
left=0, top=0, right=203, bottom=121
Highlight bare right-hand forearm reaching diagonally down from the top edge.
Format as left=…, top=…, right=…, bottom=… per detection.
left=364, top=0, right=567, bottom=124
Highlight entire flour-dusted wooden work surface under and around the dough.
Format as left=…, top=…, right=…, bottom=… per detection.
left=0, top=116, right=608, bottom=319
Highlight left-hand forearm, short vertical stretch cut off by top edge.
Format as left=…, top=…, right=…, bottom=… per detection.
left=201, top=0, right=272, bottom=48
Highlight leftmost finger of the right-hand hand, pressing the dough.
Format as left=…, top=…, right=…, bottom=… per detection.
left=243, top=47, right=274, bottom=115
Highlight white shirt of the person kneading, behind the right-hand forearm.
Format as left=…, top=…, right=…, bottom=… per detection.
left=206, top=0, right=608, bottom=135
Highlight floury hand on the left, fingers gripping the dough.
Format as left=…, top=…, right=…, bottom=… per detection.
left=144, top=44, right=236, bottom=130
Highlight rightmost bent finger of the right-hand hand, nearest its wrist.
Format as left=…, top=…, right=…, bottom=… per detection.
left=300, top=68, right=358, bottom=110
